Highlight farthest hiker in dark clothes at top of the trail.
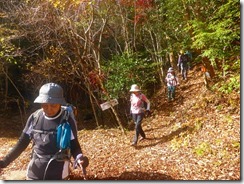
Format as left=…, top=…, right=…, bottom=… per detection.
left=177, top=51, right=189, bottom=80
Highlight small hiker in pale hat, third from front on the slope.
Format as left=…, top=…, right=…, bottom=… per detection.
left=165, top=67, right=179, bottom=101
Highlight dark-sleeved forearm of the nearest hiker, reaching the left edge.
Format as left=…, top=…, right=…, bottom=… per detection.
left=0, top=133, right=31, bottom=168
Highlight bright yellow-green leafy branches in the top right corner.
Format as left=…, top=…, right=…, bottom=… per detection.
left=192, top=1, right=240, bottom=61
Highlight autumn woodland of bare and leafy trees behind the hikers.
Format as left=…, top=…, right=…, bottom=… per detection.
left=0, top=0, right=240, bottom=127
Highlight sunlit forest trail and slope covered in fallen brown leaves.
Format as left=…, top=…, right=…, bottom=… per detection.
left=0, top=63, right=240, bottom=180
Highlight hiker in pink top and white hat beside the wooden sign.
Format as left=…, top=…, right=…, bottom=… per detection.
left=130, top=84, right=150, bottom=146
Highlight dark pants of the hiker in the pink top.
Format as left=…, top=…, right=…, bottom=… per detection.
left=132, top=113, right=146, bottom=143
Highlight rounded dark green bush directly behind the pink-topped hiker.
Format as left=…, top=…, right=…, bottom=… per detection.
left=103, top=53, right=156, bottom=98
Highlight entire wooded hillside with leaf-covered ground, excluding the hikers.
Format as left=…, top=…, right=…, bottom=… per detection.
left=0, top=0, right=241, bottom=180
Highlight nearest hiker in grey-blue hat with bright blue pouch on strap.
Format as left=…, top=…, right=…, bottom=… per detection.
left=0, top=83, right=89, bottom=180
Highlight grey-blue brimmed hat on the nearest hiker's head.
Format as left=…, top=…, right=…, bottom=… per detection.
left=34, top=83, right=66, bottom=105
